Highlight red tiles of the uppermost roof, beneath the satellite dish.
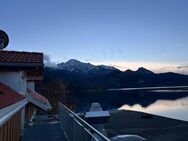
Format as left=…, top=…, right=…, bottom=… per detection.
left=0, top=51, right=43, bottom=64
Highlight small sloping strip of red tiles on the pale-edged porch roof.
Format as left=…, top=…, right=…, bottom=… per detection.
left=27, top=89, right=49, bottom=104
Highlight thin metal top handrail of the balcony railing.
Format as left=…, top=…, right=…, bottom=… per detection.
left=59, top=102, right=111, bottom=141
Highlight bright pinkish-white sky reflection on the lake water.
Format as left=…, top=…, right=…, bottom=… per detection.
left=119, top=96, right=188, bottom=121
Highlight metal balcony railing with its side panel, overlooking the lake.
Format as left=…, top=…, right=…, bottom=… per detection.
left=59, top=103, right=110, bottom=141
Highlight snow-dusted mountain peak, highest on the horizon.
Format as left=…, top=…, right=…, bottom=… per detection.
left=57, top=59, right=117, bottom=74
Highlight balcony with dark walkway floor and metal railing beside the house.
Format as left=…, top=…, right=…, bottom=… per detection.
left=22, top=103, right=110, bottom=141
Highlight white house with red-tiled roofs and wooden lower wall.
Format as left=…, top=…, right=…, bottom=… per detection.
left=0, top=51, right=51, bottom=141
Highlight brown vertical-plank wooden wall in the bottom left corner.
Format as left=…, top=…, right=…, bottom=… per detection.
left=0, top=112, right=21, bottom=141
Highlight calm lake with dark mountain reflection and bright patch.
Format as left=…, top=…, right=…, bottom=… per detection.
left=75, top=88, right=188, bottom=121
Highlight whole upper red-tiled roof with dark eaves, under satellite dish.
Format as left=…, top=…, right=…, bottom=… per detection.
left=0, top=51, right=43, bottom=81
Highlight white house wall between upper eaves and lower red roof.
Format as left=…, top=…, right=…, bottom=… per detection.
left=0, top=71, right=27, bottom=95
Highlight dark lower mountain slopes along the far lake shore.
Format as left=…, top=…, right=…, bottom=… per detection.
left=44, top=66, right=188, bottom=91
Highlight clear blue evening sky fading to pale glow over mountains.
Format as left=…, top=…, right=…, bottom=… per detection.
left=0, top=0, right=188, bottom=74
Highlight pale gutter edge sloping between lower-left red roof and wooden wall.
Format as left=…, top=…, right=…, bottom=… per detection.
left=0, top=99, right=27, bottom=127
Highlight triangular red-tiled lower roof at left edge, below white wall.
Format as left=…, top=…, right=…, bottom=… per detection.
left=0, top=83, right=25, bottom=109
